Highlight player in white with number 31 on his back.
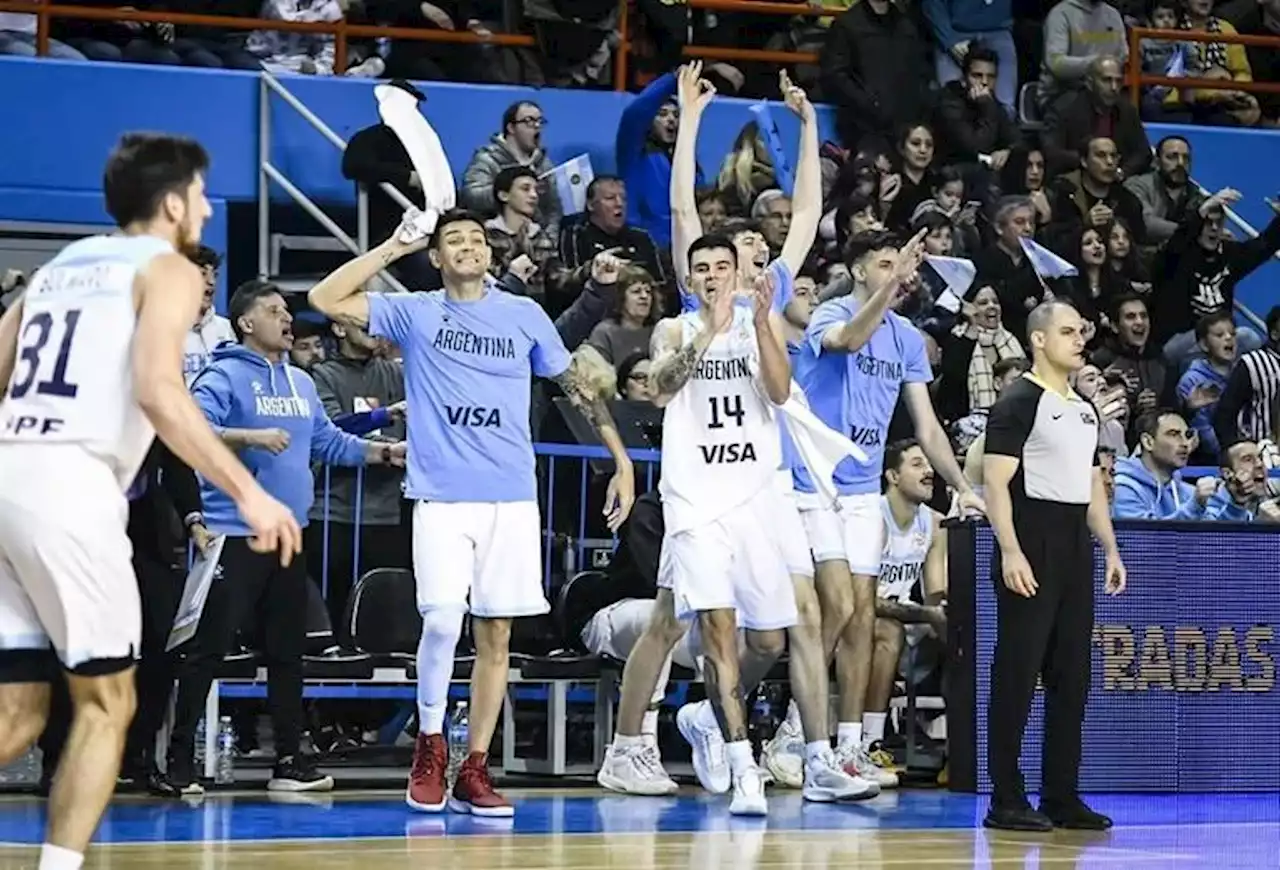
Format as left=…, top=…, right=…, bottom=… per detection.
left=0, top=133, right=302, bottom=870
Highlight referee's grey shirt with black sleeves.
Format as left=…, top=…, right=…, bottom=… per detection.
left=986, top=372, right=1098, bottom=518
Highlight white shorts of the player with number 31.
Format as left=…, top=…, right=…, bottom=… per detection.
left=0, top=444, right=142, bottom=676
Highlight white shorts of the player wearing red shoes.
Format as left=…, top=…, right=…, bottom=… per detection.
left=413, top=502, right=550, bottom=619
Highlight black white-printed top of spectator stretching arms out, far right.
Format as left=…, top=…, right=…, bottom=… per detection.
left=1151, top=210, right=1280, bottom=342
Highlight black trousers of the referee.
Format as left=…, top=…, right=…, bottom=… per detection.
left=987, top=503, right=1093, bottom=807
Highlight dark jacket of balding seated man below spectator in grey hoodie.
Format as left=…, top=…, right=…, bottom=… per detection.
left=1041, top=91, right=1151, bottom=178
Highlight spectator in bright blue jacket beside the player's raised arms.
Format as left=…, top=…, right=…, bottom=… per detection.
left=616, top=73, right=703, bottom=248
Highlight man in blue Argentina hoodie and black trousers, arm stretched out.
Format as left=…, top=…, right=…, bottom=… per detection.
left=169, top=280, right=404, bottom=795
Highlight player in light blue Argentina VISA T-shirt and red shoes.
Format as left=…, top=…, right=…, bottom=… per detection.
left=310, top=210, right=635, bottom=816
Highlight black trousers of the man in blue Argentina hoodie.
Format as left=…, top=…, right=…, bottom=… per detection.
left=169, top=537, right=307, bottom=759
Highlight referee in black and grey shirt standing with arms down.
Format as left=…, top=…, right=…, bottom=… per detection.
left=982, top=301, right=1125, bottom=830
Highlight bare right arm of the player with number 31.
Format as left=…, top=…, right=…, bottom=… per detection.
left=133, top=253, right=302, bottom=564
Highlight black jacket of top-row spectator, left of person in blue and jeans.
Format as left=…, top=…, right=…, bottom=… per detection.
left=820, top=3, right=933, bottom=147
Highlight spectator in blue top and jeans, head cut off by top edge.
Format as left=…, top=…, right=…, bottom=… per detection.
left=923, top=0, right=1018, bottom=115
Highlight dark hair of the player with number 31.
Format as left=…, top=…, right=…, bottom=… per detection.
left=102, top=133, right=209, bottom=228
